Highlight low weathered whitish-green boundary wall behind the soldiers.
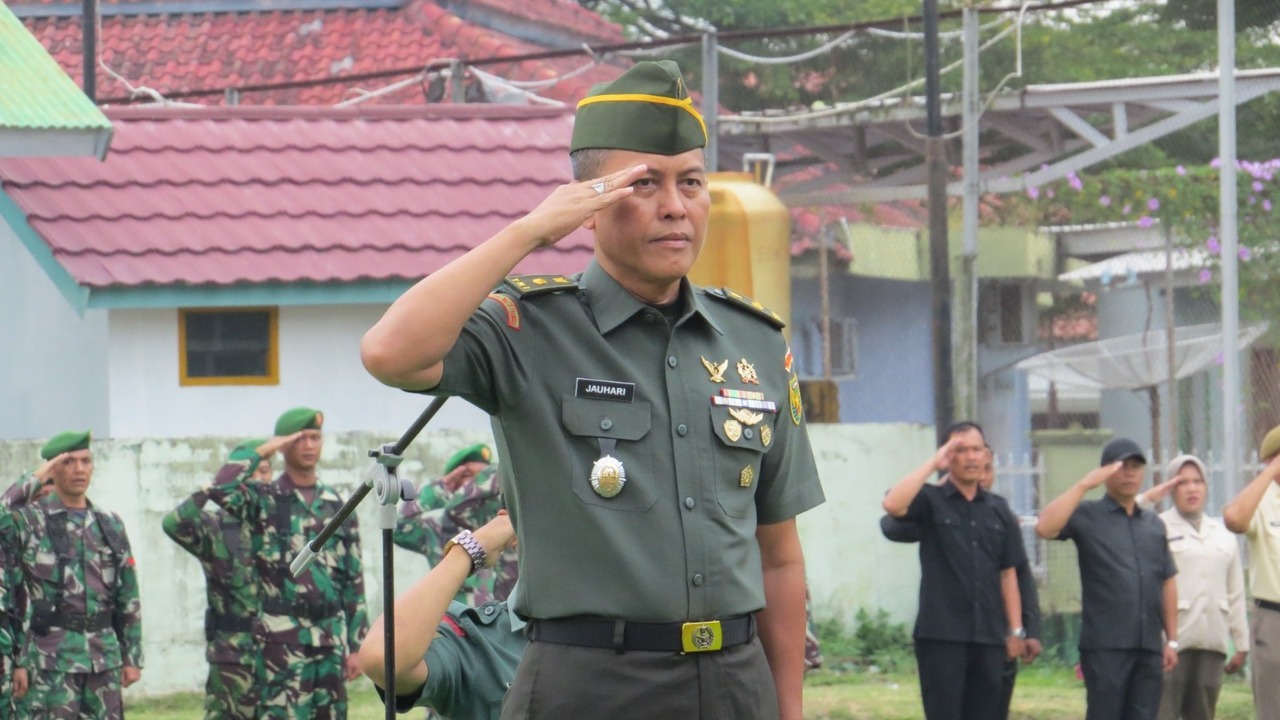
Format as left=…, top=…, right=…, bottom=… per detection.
left=0, top=425, right=933, bottom=694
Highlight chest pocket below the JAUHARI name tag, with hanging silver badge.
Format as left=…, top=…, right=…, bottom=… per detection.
left=561, top=397, right=655, bottom=512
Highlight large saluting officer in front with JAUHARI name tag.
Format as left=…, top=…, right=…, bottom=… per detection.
left=361, top=61, right=823, bottom=720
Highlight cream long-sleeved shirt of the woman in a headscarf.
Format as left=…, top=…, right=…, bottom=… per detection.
left=1160, top=509, right=1249, bottom=655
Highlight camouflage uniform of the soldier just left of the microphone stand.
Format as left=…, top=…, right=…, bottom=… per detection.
left=210, top=471, right=369, bottom=720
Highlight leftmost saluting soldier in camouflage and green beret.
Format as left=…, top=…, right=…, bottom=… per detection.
left=13, top=432, right=142, bottom=720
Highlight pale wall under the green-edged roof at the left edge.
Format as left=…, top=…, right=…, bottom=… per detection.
left=0, top=222, right=108, bottom=439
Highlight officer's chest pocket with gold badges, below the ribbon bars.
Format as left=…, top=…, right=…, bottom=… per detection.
left=710, top=405, right=777, bottom=518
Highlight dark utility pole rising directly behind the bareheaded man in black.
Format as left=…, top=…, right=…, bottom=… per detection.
left=924, top=0, right=952, bottom=441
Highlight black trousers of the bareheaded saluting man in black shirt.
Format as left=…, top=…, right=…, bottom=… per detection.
left=915, top=638, right=1005, bottom=720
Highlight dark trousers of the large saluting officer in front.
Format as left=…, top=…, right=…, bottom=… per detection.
left=502, top=638, right=778, bottom=720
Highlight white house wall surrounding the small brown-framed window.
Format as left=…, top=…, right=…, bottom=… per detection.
left=106, top=305, right=489, bottom=438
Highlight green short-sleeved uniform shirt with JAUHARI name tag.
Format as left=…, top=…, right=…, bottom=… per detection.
left=431, top=261, right=823, bottom=621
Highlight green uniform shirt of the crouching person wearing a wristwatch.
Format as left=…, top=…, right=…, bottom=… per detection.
left=378, top=602, right=529, bottom=720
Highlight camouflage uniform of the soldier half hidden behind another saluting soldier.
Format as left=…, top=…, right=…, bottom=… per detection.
left=164, top=461, right=262, bottom=720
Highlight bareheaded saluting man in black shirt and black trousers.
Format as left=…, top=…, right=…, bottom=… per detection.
left=884, top=423, right=1027, bottom=720
